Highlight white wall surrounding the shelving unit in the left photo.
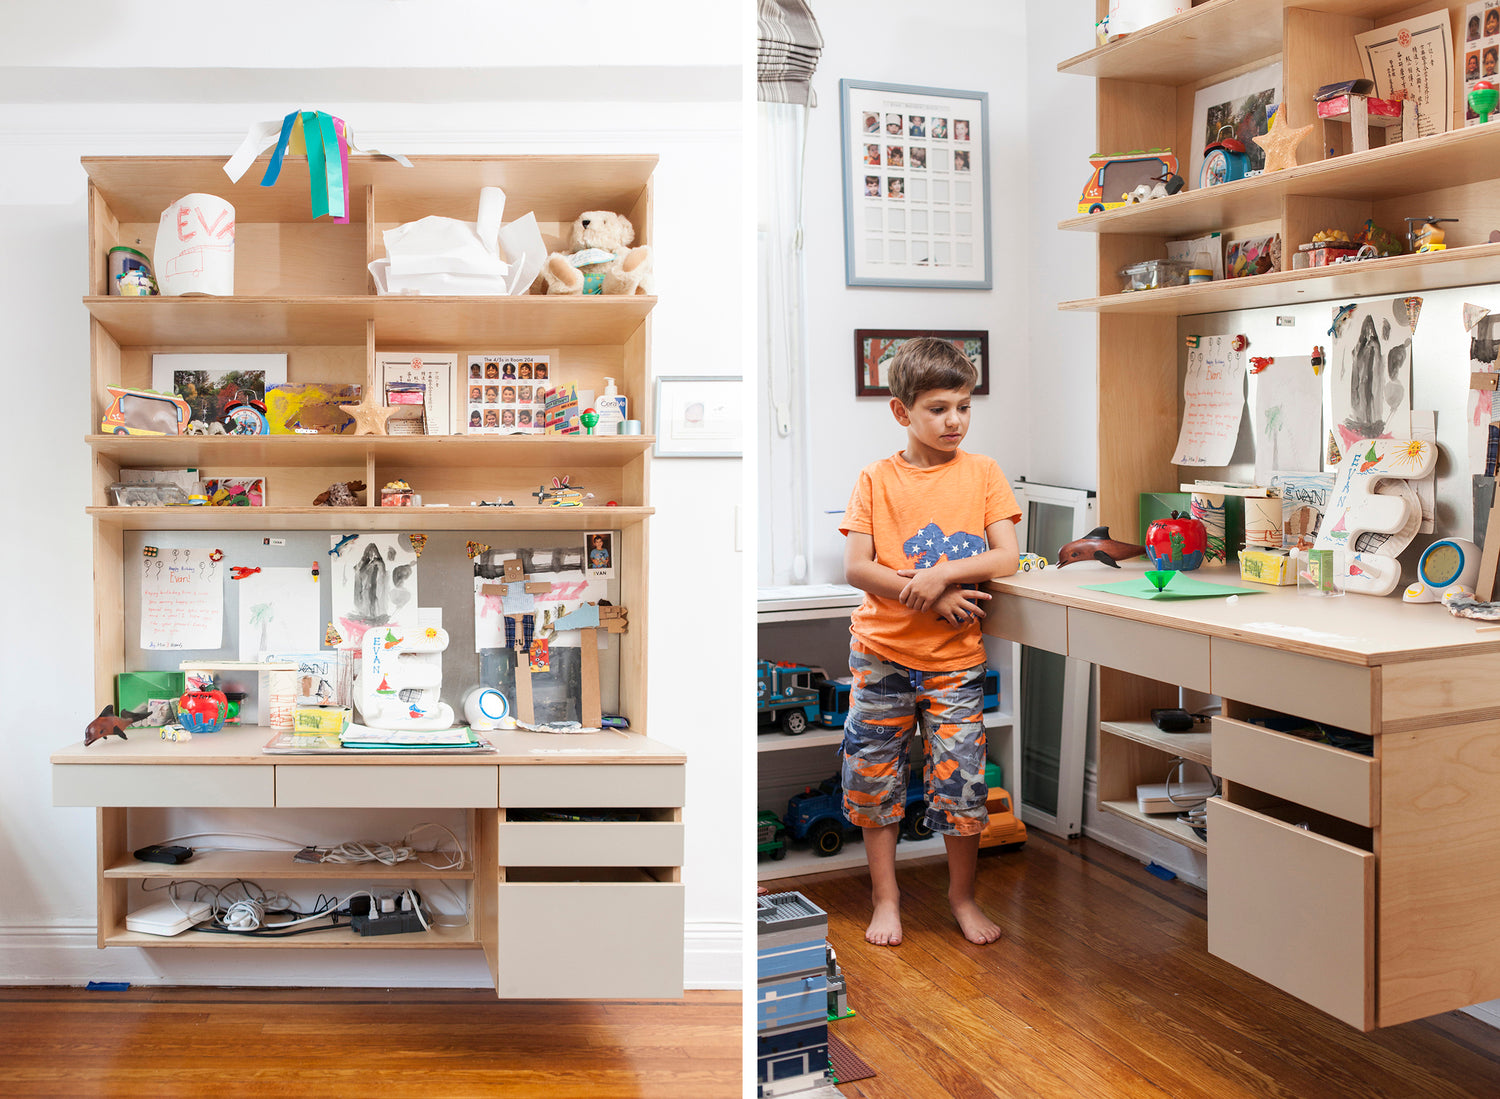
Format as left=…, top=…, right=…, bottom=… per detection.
left=0, top=0, right=749, bottom=988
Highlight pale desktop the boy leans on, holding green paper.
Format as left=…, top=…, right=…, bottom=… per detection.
left=987, top=558, right=1500, bottom=666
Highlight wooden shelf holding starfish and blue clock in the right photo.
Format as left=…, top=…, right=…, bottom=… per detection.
left=1058, top=125, right=1500, bottom=238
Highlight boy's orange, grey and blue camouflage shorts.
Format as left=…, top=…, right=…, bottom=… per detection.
left=843, top=648, right=989, bottom=835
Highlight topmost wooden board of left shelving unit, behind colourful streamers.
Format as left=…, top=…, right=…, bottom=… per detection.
left=83, top=154, right=657, bottom=229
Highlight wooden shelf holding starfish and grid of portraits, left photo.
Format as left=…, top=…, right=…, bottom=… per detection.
left=84, top=435, right=656, bottom=469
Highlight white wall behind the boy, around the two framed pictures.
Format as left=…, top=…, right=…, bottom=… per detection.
left=762, top=0, right=1031, bottom=583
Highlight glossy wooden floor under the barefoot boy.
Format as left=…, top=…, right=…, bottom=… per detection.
left=767, top=829, right=1500, bottom=1099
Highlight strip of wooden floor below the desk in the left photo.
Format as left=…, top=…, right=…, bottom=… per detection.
left=0, top=988, right=743, bottom=1099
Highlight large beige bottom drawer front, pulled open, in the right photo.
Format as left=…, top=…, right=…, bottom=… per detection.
left=1209, top=797, right=1376, bottom=1030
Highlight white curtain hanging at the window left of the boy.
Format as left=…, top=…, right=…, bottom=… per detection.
left=756, top=102, right=812, bottom=586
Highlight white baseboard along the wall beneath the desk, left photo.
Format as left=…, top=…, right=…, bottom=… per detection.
left=0, top=922, right=744, bottom=991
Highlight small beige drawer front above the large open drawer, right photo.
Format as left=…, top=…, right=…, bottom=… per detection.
left=1214, top=717, right=1380, bottom=828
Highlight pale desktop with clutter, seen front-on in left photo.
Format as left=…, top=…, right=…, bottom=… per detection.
left=51, top=726, right=687, bottom=768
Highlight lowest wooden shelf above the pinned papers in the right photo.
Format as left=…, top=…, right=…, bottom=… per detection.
left=1058, top=244, right=1500, bottom=316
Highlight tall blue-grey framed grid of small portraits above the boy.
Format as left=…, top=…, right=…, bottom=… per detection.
left=839, top=79, right=992, bottom=289
